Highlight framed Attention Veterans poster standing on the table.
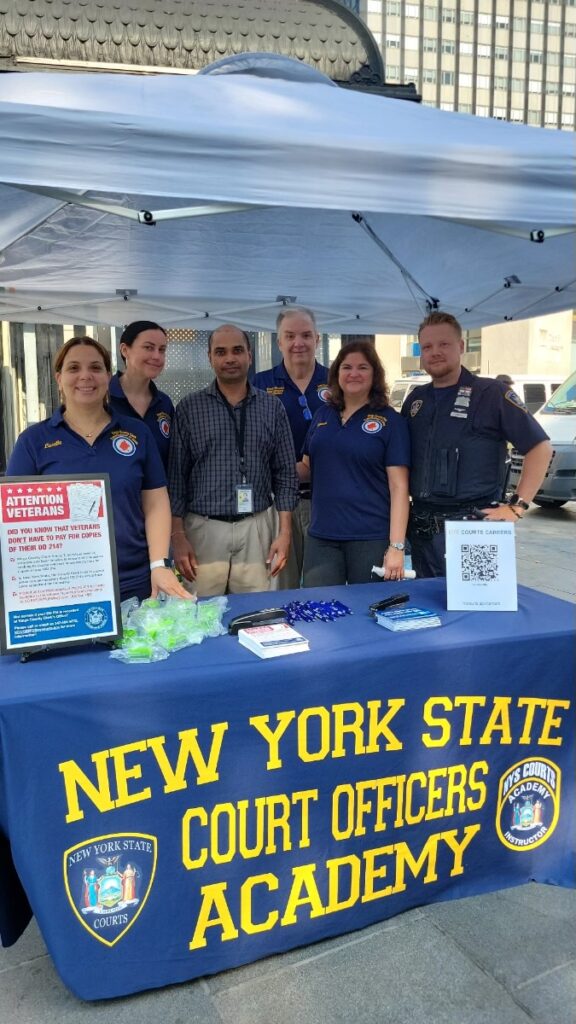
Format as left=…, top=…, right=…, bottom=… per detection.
left=0, top=473, right=122, bottom=654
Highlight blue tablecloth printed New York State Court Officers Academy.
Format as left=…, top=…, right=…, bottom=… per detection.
left=0, top=581, right=574, bottom=999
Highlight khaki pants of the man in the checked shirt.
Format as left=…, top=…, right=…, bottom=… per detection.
left=184, top=506, right=276, bottom=597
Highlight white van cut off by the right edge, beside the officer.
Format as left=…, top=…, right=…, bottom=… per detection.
left=508, top=371, right=576, bottom=509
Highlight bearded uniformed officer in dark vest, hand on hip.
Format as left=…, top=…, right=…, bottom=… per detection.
left=402, top=310, right=551, bottom=577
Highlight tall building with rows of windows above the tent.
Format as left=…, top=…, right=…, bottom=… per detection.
left=360, top=0, right=576, bottom=131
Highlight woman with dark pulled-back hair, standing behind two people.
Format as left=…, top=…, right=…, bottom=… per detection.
left=110, top=321, right=174, bottom=469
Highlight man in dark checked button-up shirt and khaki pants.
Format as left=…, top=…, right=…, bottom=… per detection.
left=169, top=324, right=298, bottom=597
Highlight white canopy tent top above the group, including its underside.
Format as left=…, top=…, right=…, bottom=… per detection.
left=0, top=74, right=576, bottom=334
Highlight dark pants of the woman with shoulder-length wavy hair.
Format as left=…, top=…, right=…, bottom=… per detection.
left=303, top=534, right=388, bottom=587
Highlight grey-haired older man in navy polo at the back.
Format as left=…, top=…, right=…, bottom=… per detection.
left=253, top=306, right=328, bottom=590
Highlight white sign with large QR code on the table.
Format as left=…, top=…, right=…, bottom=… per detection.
left=445, top=519, right=518, bottom=611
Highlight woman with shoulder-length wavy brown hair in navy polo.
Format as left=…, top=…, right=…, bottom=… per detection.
left=303, top=342, right=410, bottom=587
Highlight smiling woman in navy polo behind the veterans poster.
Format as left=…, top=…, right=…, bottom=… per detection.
left=6, top=337, right=190, bottom=600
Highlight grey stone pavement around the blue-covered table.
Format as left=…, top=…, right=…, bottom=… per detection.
left=0, top=503, right=576, bottom=1024
